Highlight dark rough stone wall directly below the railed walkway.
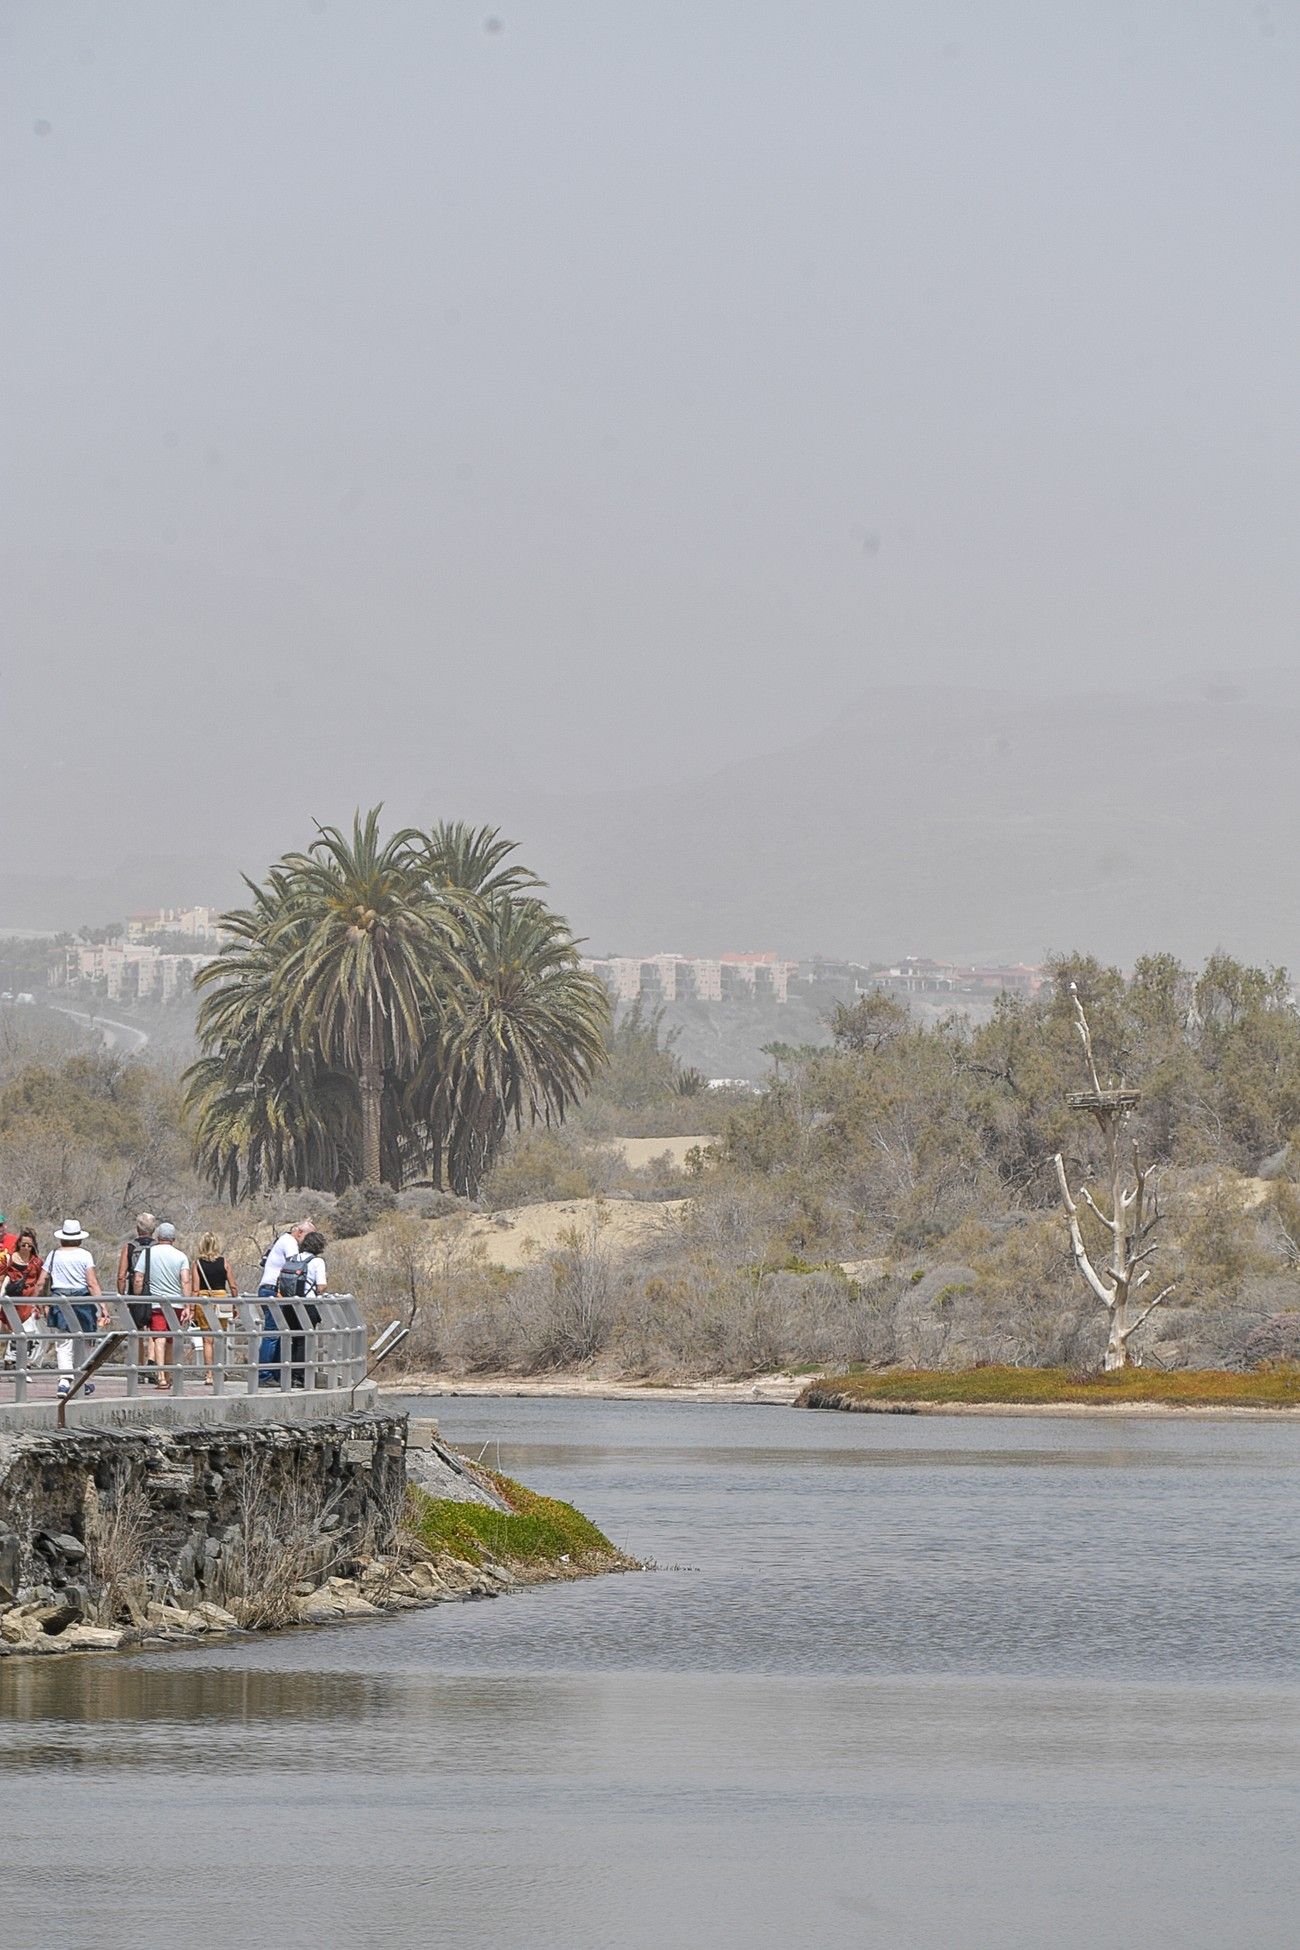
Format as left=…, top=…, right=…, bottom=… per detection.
left=0, top=1410, right=405, bottom=1650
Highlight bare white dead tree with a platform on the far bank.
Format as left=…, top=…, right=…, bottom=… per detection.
left=1056, top=983, right=1173, bottom=1371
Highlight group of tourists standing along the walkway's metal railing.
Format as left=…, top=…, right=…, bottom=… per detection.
left=0, top=1213, right=327, bottom=1394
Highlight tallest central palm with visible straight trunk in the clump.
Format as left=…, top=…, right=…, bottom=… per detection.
left=273, top=805, right=464, bottom=1186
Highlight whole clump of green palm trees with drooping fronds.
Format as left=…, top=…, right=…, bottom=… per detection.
left=185, top=807, right=608, bottom=1199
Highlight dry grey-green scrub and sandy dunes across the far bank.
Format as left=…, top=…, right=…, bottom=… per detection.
left=0, top=936, right=1300, bottom=1379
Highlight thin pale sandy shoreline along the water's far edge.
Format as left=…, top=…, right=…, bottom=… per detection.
left=380, top=1375, right=1300, bottom=1422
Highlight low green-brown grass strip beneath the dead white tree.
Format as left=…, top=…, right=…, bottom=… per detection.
left=799, top=1361, right=1300, bottom=1408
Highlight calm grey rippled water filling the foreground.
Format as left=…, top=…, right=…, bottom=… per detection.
left=0, top=1400, right=1300, bottom=1950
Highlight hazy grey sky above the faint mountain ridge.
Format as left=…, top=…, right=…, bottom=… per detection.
left=0, top=0, right=1300, bottom=918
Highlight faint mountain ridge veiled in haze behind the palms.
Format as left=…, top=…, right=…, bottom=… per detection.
left=10, top=679, right=1300, bottom=982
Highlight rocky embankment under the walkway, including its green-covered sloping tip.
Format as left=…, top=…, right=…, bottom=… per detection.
left=0, top=1412, right=630, bottom=1658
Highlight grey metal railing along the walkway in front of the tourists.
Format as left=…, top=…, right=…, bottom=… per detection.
left=0, top=1293, right=370, bottom=1404
